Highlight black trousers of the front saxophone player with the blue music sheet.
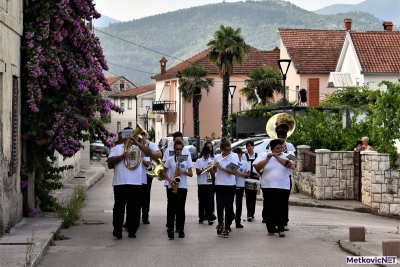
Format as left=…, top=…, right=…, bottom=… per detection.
left=167, top=188, right=187, bottom=231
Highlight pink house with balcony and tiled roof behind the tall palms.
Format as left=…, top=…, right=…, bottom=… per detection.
left=152, top=48, right=279, bottom=141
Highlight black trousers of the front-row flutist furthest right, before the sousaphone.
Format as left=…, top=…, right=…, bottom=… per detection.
left=262, top=188, right=290, bottom=233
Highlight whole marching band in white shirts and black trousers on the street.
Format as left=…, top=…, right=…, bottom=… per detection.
left=107, top=114, right=295, bottom=239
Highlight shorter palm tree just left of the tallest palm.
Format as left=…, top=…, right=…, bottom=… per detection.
left=178, top=65, right=214, bottom=140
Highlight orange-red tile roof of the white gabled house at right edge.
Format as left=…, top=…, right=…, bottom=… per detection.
left=350, top=31, right=400, bottom=73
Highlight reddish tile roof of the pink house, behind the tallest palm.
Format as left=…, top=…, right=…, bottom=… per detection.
left=152, top=47, right=280, bottom=79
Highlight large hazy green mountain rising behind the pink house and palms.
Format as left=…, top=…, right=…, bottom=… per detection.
left=95, top=0, right=383, bottom=85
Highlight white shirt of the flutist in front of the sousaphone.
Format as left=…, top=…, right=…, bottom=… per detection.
left=253, top=152, right=291, bottom=190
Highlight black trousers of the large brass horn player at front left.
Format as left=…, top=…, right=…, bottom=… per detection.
left=113, top=184, right=142, bottom=233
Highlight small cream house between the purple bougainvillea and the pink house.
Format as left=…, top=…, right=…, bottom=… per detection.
left=109, top=84, right=156, bottom=133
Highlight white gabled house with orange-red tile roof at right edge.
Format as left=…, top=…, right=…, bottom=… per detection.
left=328, top=21, right=400, bottom=89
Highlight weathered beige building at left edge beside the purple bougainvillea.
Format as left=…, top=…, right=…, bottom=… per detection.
left=0, top=0, right=23, bottom=235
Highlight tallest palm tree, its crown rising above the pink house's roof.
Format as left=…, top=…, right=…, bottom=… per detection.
left=207, top=25, right=251, bottom=136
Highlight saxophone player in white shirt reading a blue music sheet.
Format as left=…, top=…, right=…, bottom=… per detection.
left=164, top=140, right=193, bottom=239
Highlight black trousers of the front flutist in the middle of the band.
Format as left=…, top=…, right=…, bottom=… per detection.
left=215, top=185, right=235, bottom=229
